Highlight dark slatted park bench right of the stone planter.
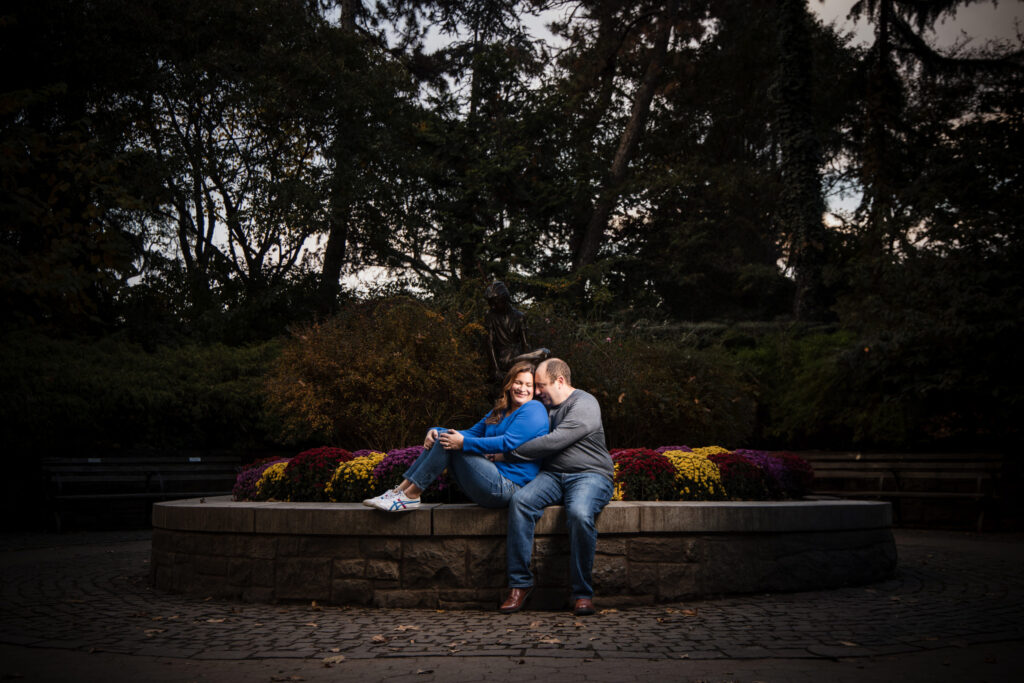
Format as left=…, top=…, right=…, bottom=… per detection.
left=801, top=453, right=1004, bottom=530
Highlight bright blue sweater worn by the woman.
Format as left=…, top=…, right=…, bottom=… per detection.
left=461, top=400, right=548, bottom=486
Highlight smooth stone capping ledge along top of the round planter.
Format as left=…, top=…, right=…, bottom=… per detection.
left=153, top=496, right=892, bottom=537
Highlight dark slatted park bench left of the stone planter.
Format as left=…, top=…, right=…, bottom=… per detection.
left=42, top=453, right=241, bottom=530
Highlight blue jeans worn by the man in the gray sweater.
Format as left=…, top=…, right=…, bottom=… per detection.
left=507, top=471, right=613, bottom=600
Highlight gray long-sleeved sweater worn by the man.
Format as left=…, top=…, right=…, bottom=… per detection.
left=506, top=389, right=614, bottom=479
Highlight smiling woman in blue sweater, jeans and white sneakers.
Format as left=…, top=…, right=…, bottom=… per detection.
left=362, top=361, right=548, bottom=512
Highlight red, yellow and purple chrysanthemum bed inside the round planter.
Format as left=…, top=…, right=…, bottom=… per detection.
left=234, top=445, right=814, bottom=503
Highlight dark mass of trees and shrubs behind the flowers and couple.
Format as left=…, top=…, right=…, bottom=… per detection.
left=0, top=0, right=1024, bottom=481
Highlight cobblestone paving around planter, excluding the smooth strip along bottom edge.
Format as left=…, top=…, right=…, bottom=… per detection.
left=0, top=530, right=1024, bottom=680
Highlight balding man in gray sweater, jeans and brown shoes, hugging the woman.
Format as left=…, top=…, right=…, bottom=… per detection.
left=491, top=358, right=614, bottom=616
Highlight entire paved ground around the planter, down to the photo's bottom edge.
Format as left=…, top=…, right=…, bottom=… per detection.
left=0, top=530, right=1024, bottom=683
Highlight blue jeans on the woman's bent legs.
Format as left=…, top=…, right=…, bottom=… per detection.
left=406, top=441, right=519, bottom=508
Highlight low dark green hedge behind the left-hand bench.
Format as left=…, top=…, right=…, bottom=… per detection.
left=0, top=333, right=278, bottom=453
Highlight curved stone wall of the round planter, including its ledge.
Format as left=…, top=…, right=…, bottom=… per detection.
left=152, top=497, right=896, bottom=609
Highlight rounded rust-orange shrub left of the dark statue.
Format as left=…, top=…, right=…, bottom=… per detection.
left=264, top=297, right=487, bottom=449
